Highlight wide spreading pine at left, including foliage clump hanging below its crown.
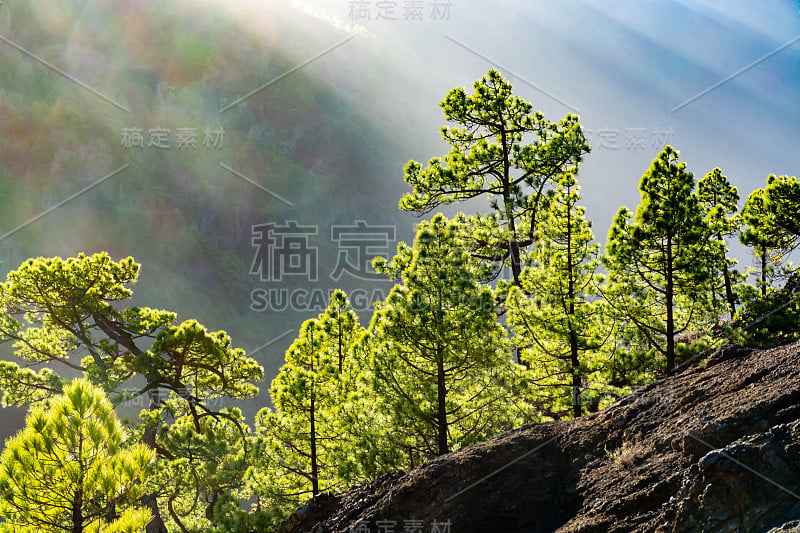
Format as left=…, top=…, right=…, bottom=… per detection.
left=0, top=253, right=263, bottom=531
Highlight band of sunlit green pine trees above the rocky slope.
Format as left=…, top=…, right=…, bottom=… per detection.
left=0, top=70, right=800, bottom=533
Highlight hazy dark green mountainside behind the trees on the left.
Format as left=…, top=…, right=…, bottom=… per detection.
left=0, top=0, right=419, bottom=388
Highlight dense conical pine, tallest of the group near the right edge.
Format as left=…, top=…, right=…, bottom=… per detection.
left=604, top=146, right=719, bottom=373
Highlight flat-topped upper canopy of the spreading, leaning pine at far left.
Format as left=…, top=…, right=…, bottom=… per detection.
left=0, top=249, right=263, bottom=403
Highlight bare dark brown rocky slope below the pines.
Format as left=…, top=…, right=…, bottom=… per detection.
left=281, top=344, right=800, bottom=533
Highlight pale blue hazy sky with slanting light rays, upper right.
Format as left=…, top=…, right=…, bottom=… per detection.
left=282, top=0, right=800, bottom=261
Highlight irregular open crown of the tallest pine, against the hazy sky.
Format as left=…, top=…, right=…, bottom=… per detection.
left=400, top=70, right=589, bottom=283
